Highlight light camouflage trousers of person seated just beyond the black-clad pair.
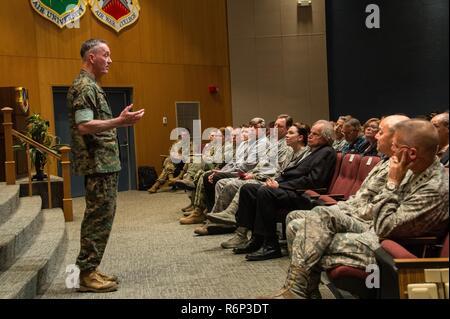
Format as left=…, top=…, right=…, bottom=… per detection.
left=211, top=178, right=262, bottom=215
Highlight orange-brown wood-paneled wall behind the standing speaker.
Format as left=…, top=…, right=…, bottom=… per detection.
left=0, top=0, right=232, bottom=172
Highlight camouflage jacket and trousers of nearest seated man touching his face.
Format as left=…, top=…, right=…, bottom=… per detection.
left=288, top=159, right=449, bottom=284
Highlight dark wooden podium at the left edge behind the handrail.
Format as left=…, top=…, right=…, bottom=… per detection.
left=0, top=87, right=29, bottom=182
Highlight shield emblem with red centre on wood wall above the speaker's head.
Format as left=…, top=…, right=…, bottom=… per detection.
left=90, top=0, right=141, bottom=32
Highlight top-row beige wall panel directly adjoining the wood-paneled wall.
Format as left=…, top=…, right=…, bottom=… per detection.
left=228, top=0, right=255, bottom=39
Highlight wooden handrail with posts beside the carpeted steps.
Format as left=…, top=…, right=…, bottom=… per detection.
left=2, top=107, right=73, bottom=222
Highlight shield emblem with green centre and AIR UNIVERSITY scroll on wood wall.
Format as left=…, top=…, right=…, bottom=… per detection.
left=30, top=0, right=88, bottom=28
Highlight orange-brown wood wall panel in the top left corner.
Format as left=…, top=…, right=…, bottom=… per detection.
left=0, top=0, right=36, bottom=56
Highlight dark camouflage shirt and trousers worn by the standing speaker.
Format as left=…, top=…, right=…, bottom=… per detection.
left=67, top=70, right=120, bottom=271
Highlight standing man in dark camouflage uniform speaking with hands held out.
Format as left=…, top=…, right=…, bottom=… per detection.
left=67, top=39, right=144, bottom=292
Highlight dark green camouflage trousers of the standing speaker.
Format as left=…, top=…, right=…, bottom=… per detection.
left=76, top=173, right=119, bottom=271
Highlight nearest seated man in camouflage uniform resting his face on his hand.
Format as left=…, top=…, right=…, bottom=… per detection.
left=272, top=120, right=449, bottom=298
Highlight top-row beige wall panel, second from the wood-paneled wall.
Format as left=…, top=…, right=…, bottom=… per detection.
left=254, top=0, right=281, bottom=37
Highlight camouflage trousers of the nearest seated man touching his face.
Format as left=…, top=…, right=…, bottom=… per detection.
left=286, top=205, right=376, bottom=271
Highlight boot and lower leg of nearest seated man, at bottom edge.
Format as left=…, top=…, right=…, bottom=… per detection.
left=258, top=264, right=308, bottom=299
